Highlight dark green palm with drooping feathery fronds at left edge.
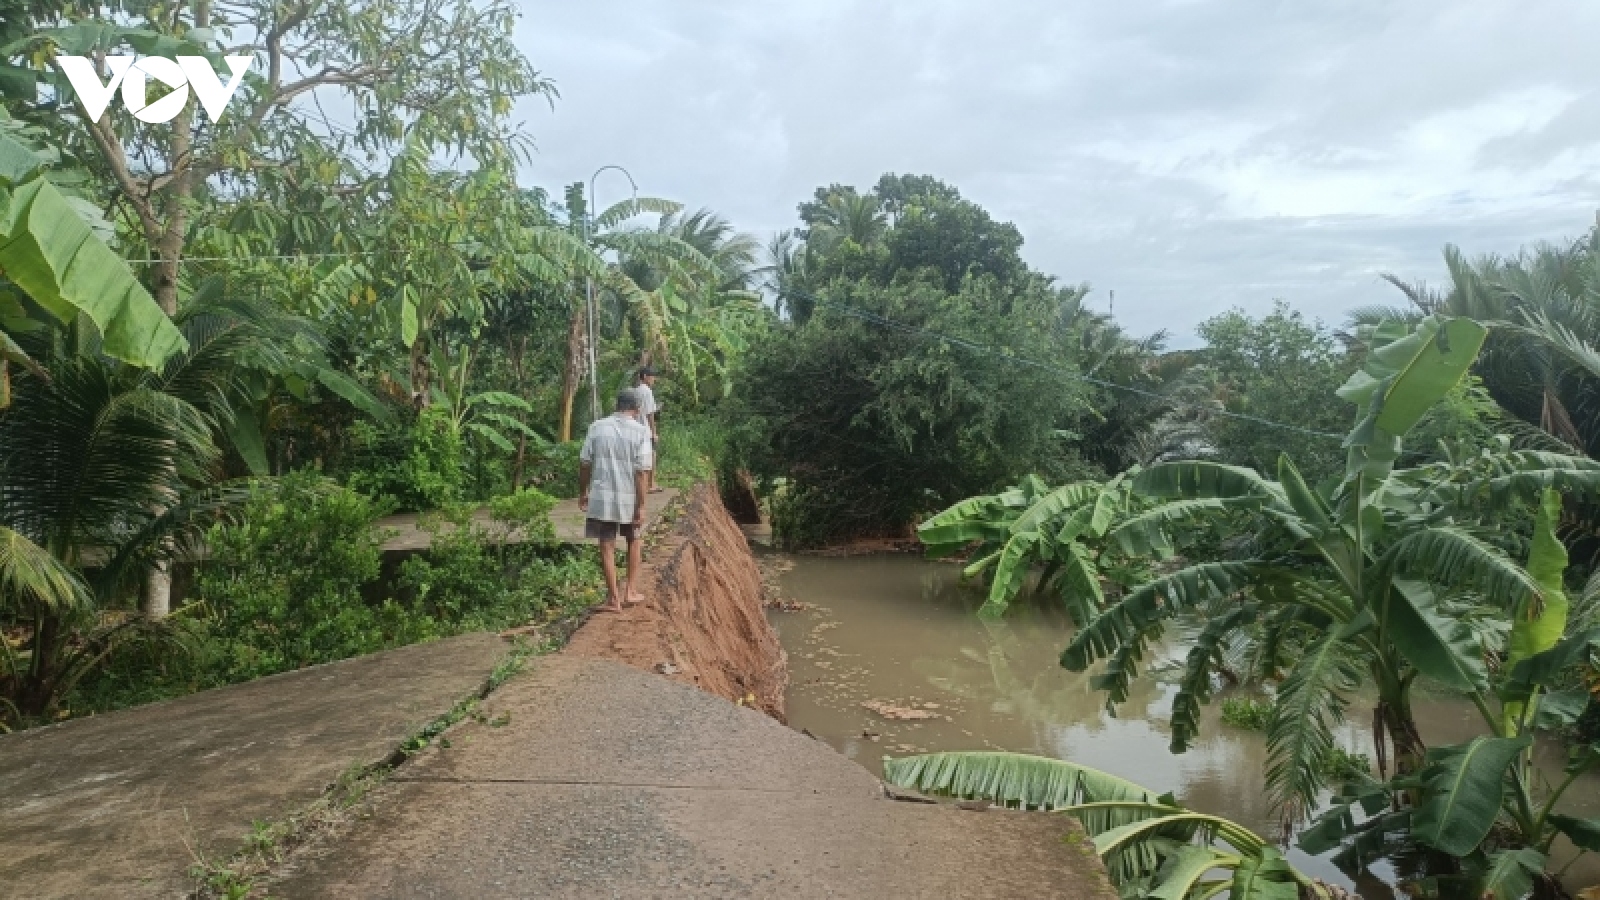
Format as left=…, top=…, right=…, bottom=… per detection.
left=0, top=294, right=288, bottom=716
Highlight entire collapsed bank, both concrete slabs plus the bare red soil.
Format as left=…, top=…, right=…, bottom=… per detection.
left=0, top=488, right=1114, bottom=898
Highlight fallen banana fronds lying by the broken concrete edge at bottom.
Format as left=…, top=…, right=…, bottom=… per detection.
left=883, top=753, right=1331, bottom=900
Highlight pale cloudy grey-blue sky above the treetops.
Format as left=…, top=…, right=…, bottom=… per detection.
left=518, top=0, right=1600, bottom=346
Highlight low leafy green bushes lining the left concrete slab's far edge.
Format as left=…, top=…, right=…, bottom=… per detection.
left=67, top=472, right=602, bottom=711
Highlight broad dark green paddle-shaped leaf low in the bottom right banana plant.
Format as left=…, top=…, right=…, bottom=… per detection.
left=1411, top=735, right=1533, bottom=857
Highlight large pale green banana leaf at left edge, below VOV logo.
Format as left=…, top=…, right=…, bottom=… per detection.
left=0, top=179, right=187, bottom=368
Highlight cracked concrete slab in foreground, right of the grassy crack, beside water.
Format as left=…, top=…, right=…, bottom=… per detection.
left=269, top=657, right=1115, bottom=900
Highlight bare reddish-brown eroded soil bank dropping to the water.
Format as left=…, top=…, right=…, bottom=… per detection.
left=565, top=485, right=789, bottom=721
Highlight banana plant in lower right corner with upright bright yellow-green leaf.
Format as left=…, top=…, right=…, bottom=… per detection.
left=1301, top=490, right=1600, bottom=900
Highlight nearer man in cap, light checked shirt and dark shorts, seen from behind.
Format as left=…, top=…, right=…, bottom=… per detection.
left=578, top=391, right=656, bottom=612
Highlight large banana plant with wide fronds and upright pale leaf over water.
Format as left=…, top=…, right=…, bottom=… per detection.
left=923, top=317, right=1600, bottom=822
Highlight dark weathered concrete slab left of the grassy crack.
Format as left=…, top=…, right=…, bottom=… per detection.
left=0, top=634, right=507, bottom=898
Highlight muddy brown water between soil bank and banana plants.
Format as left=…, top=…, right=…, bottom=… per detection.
left=771, top=556, right=1600, bottom=898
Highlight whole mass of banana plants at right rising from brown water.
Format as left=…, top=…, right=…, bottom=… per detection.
left=922, top=315, right=1600, bottom=897
